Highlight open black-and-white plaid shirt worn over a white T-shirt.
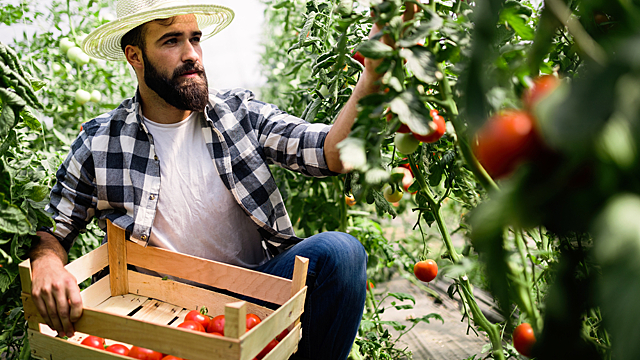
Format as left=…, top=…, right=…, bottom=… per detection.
left=48, top=89, right=335, bottom=251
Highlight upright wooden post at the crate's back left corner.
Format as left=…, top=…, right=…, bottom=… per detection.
left=107, top=220, right=128, bottom=296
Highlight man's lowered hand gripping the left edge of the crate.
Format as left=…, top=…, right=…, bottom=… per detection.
left=31, top=232, right=82, bottom=337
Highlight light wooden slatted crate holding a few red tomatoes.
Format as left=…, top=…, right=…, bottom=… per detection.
left=20, top=222, right=308, bottom=360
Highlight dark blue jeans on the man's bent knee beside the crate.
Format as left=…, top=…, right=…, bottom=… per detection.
left=255, top=232, right=367, bottom=360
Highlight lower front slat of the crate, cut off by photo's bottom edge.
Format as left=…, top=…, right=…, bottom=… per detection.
left=27, top=329, right=131, bottom=360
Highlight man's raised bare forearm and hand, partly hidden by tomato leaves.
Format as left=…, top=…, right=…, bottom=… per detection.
left=324, top=3, right=419, bottom=172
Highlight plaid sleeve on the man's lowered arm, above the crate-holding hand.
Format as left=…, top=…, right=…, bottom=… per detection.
left=46, top=131, right=97, bottom=252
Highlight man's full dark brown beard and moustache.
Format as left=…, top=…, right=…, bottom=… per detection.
left=142, top=51, right=209, bottom=111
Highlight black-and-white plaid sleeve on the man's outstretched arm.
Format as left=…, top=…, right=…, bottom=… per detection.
left=249, top=95, right=338, bottom=177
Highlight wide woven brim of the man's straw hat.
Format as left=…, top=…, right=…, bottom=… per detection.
left=82, top=4, right=235, bottom=61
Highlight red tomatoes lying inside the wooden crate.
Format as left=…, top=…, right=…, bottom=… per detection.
left=73, top=310, right=289, bottom=360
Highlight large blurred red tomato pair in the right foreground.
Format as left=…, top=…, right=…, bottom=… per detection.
left=473, top=75, right=560, bottom=179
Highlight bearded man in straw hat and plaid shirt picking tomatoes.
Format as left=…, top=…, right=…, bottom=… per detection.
left=31, top=0, right=418, bottom=359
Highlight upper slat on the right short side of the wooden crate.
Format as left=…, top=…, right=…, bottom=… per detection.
left=241, top=286, right=307, bottom=360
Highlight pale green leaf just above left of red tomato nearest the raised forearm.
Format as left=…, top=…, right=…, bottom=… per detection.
left=389, top=88, right=431, bottom=135
